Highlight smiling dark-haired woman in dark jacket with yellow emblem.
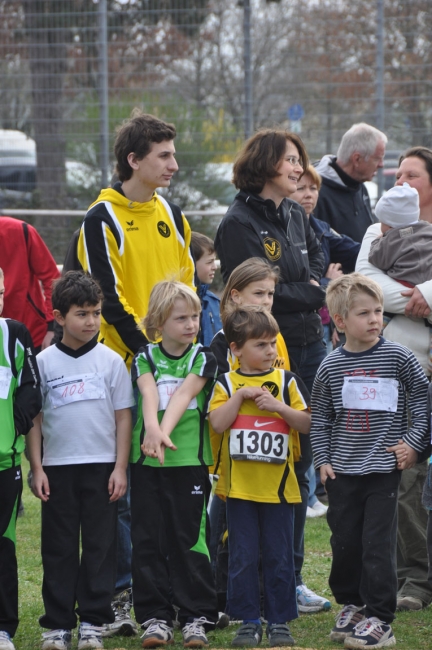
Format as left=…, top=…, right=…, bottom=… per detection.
left=215, top=129, right=330, bottom=612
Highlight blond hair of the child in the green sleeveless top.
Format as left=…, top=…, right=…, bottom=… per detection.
left=141, top=280, right=201, bottom=341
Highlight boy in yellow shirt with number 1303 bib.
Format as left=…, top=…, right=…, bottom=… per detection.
left=209, top=306, right=310, bottom=647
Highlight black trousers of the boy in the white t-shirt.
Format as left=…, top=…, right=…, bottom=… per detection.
left=39, top=463, right=117, bottom=630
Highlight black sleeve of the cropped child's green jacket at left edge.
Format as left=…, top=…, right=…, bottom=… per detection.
left=8, top=321, right=42, bottom=435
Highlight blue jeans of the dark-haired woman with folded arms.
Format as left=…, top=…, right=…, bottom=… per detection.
left=288, top=340, right=327, bottom=585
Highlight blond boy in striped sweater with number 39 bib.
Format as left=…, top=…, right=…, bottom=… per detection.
left=311, top=273, right=428, bottom=648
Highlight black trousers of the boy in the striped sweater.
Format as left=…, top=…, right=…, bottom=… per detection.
left=326, top=471, right=401, bottom=623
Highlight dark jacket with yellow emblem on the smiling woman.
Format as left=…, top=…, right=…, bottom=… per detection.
left=215, top=192, right=325, bottom=352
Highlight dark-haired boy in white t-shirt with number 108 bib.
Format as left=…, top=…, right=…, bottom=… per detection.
left=28, top=271, right=134, bottom=650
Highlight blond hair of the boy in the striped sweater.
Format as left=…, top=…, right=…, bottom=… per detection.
left=326, top=273, right=384, bottom=318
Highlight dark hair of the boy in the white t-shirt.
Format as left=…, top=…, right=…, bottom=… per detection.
left=52, top=271, right=103, bottom=317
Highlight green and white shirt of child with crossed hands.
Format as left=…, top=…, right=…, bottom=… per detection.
left=130, top=343, right=217, bottom=467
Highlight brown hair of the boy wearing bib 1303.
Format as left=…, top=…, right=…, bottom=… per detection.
left=224, top=305, right=279, bottom=349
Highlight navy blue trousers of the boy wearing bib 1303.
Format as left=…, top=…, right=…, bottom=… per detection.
left=227, top=498, right=297, bottom=624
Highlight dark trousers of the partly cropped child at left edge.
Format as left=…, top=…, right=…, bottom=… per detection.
left=0, top=466, right=22, bottom=637
